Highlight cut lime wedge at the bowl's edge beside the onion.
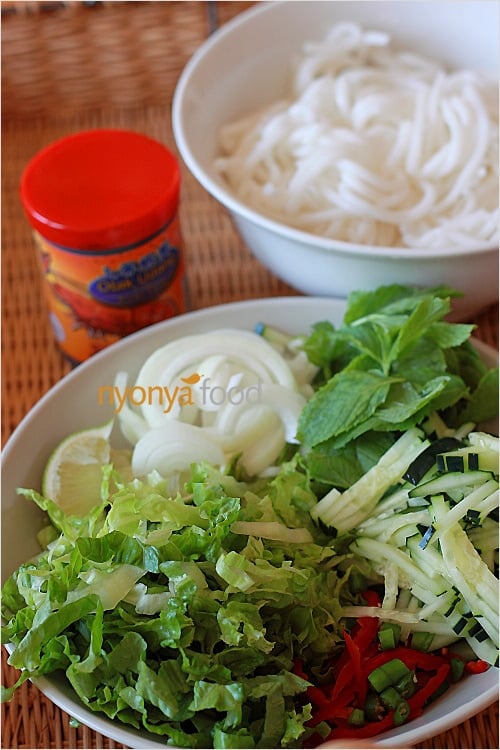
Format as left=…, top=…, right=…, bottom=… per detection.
left=42, top=420, right=113, bottom=516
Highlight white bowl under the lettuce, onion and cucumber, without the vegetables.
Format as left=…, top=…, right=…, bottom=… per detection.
left=1, top=297, right=498, bottom=748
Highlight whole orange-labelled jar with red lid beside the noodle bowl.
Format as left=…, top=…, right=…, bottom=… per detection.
left=21, top=129, right=185, bottom=363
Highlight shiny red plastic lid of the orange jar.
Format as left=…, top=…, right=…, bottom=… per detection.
left=21, top=129, right=180, bottom=250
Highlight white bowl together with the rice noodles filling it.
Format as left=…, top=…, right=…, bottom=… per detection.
left=172, top=0, right=499, bottom=318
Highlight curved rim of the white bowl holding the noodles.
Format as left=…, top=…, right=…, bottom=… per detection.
left=171, top=0, right=499, bottom=262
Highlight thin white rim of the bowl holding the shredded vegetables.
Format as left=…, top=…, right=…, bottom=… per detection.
left=1, top=295, right=498, bottom=749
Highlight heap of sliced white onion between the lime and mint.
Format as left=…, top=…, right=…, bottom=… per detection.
left=115, top=329, right=316, bottom=483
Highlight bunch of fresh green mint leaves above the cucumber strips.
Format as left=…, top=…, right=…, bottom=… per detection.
left=298, top=285, right=498, bottom=478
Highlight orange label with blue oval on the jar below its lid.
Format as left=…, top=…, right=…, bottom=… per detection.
left=34, top=217, right=185, bottom=362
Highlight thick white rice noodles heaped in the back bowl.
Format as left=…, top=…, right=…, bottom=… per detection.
left=216, top=23, right=499, bottom=249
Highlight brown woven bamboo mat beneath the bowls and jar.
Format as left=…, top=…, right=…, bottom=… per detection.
left=2, top=2, right=498, bottom=748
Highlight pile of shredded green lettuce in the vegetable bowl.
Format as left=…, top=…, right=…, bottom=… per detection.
left=3, top=460, right=357, bottom=748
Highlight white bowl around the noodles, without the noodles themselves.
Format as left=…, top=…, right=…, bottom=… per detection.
left=172, top=0, right=499, bottom=317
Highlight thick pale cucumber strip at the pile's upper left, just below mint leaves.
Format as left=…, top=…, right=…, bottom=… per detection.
left=311, top=428, right=429, bottom=533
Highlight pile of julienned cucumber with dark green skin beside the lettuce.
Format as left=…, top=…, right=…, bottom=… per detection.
left=313, top=430, right=500, bottom=665
